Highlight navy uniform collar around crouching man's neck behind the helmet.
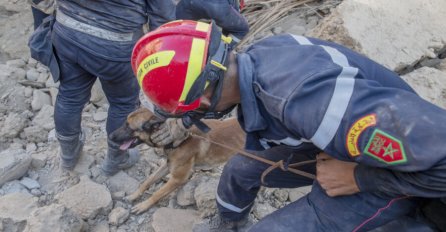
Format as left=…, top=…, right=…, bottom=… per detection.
left=237, top=53, right=267, bottom=132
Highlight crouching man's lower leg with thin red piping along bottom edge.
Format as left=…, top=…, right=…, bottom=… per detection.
left=250, top=182, right=429, bottom=232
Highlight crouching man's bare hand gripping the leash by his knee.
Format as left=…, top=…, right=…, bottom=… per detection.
left=316, top=153, right=360, bottom=197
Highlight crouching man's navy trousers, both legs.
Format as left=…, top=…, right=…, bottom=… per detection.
left=217, top=146, right=432, bottom=232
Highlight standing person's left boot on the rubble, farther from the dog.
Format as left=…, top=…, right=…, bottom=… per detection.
left=56, top=131, right=85, bottom=170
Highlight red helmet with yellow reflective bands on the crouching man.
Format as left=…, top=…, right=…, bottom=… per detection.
left=132, top=20, right=231, bottom=114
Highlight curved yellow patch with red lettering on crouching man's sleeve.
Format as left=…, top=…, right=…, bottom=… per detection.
left=345, top=114, right=376, bottom=157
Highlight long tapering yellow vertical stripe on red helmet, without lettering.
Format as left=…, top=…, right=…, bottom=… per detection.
left=179, top=38, right=206, bottom=102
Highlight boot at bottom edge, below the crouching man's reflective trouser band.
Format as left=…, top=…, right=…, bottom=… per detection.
left=192, top=214, right=254, bottom=232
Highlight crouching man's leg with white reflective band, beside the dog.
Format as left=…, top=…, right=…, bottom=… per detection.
left=217, top=146, right=317, bottom=221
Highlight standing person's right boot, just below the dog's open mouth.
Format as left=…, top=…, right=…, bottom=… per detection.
left=102, top=139, right=139, bottom=176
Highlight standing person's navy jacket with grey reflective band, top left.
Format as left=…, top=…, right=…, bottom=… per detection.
left=54, top=0, right=175, bottom=62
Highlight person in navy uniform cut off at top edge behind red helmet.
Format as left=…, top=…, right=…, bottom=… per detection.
left=176, top=0, right=249, bottom=42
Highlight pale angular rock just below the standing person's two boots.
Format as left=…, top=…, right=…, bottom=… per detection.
left=56, top=176, right=113, bottom=219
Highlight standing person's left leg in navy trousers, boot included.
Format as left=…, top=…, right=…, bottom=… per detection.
left=53, top=34, right=96, bottom=169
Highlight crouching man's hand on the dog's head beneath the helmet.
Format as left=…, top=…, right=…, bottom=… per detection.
left=150, top=118, right=189, bottom=147
